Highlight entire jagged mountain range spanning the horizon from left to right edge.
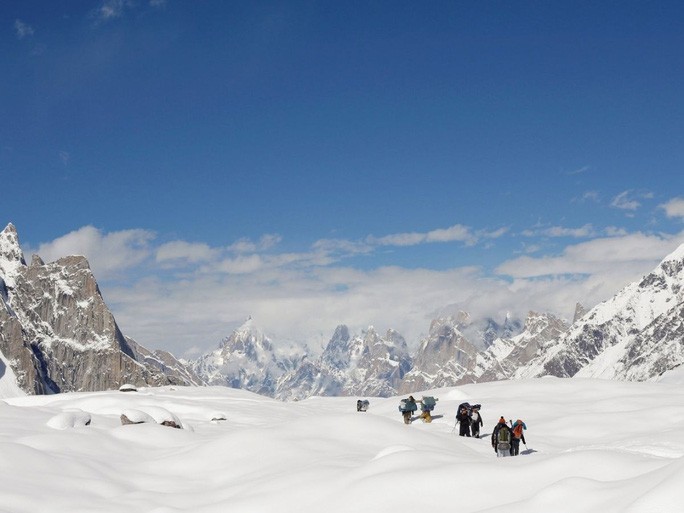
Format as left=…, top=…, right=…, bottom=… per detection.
left=0, top=224, right=684, bottom=400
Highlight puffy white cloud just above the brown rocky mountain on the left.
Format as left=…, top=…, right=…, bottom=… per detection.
left=36, top=226, right=155, bottom=279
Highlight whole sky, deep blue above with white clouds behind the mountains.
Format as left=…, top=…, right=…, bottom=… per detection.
left=0, top=0, right=684, bottom=356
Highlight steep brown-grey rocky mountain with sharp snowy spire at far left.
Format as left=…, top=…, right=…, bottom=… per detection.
left=0, top=224, right=201, bottom=394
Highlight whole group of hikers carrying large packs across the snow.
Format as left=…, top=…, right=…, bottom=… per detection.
left=390, top=395, right=527, bottom=457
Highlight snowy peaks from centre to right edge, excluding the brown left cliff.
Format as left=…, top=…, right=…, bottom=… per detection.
left=188, top=238, right=684, bottom=399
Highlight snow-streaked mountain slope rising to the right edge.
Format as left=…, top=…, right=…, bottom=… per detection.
left=515, top=245, right=684, bottom=381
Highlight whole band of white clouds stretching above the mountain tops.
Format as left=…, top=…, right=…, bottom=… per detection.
left=34, top=222, right=684, bottom=357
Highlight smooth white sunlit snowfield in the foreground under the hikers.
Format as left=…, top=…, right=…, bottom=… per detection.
left=0, top=374, right=684, bottom=513
